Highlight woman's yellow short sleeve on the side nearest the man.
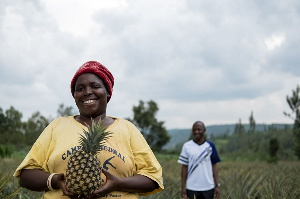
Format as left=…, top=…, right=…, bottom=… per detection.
left=128, top=122, right=164, bottom=196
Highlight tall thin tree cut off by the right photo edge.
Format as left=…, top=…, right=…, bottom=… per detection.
left=284, top=85, right=300, bottom=159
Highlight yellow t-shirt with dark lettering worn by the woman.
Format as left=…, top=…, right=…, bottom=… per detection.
left=14, top=116, right=164, bottom=199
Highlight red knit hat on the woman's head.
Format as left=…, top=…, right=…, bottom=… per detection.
left=71, top=61, right=114, bottom=102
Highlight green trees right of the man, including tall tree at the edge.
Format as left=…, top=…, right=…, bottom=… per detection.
left=213, top=86, right=300, bottom=162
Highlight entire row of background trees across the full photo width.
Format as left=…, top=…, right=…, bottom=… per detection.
left=0, top=86, right=300, bottom=160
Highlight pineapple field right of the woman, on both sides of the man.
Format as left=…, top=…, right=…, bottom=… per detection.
left=145, top=159, right=300, bottom=199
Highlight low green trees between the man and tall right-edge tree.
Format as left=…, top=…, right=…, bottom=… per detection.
left=217, top=116, right=296, bottom=162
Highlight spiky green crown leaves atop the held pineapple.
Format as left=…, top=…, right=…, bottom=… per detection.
left=79, top=120, right=112, bottom=155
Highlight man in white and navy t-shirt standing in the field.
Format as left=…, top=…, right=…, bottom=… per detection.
left=178, top=121, right=221, bottom=199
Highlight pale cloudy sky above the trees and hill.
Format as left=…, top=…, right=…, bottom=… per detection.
left=0, top=0, right=300, bottom=129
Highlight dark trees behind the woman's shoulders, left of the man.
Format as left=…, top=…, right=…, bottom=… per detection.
left=0, top=100, right=170, bottom=157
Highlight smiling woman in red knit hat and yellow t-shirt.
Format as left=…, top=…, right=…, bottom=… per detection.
left=14, top=61, right=164, bottom=199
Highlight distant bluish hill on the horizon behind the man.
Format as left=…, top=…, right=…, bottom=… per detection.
left=163, top=124, right=293, bottom=150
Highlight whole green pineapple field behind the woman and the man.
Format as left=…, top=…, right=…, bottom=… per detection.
left=0, top=154, right=300, bottom=199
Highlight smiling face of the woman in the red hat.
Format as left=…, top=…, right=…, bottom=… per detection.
left=74, top=73, right=109, bottom=118
